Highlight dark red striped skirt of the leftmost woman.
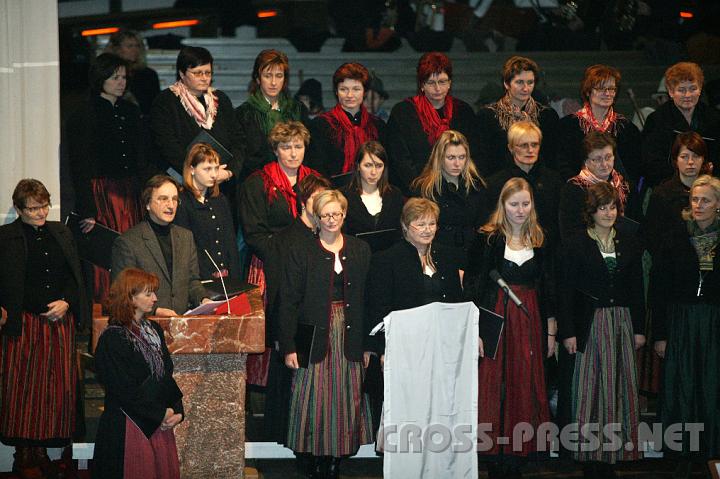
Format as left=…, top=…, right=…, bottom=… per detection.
left=0, top=313, right=77, bottom=447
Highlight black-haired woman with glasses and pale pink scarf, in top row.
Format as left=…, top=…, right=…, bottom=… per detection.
left=150, top=46, right=245, bottom=192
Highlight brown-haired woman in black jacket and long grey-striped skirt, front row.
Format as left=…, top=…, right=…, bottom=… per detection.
left=558, top=182, right=645, bottom=478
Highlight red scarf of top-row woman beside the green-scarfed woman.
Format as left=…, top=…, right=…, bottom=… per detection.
left=319, top=103, right=378, bottom=173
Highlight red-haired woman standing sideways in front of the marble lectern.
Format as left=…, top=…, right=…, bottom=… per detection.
left=92, top=268, right=184, bottom=479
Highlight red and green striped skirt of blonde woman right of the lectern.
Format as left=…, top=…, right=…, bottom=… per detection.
left=287, top=301, right=373, bottom=457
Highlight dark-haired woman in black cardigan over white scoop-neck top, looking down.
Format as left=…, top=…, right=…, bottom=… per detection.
left=341, top=141, right=403, bottom=252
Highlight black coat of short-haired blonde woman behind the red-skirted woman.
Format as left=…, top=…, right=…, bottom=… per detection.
left=488, top=163, right=563, bottom=246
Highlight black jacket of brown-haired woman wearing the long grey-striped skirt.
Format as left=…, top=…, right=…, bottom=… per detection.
left=557, top=231, right=645, bottom=352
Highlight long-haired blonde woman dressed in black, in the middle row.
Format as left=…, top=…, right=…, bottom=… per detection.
left=411, top=130, right=489, bottom=263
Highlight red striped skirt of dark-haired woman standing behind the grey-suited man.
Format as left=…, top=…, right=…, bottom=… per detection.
left=90, top=178, right=142, bottom=304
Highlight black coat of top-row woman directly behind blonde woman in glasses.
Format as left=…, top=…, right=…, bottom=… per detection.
left=473, top=104, right=558, bottom=176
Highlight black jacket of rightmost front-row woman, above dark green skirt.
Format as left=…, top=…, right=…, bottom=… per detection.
left=648, top=225, right=720, bottom=341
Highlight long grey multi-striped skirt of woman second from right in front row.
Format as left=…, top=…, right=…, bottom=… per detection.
left=571, top=307, right=640, bottom=464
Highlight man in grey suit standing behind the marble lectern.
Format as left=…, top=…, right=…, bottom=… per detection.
left=112, top=175, right=209, bottom=316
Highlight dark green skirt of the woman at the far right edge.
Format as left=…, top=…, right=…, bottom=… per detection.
left=660, top=304, right=720, bottom=458
